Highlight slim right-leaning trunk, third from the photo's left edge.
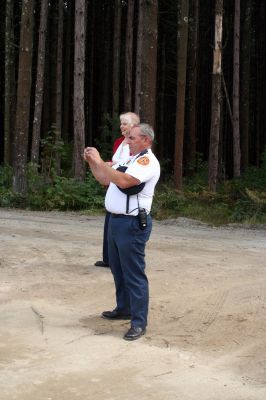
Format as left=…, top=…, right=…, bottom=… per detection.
left=31, top=0, right=49, bottom=165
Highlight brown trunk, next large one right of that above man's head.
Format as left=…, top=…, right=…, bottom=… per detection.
left=174, top=0, right=189, bottom=189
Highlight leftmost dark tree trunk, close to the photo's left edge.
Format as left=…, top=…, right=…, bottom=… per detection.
left=4, top=0, right=15, bottom=164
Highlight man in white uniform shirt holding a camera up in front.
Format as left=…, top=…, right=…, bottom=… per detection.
left=84, top=124, right=160, bottom=340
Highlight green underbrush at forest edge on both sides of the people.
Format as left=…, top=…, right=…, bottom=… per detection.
left=0, top=157, right=266, bottom=225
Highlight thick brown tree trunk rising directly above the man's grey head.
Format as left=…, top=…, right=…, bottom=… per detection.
left=135, top=0, right=158, bottom=126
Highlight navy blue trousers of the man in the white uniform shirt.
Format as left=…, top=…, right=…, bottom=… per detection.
left=108, top=214, right=152, bottom=328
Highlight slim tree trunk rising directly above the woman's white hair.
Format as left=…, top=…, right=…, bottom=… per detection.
left=124, top=0, right=135, bottom=111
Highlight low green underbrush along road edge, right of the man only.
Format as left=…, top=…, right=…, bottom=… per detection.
left=153, top=184, right=266, bottom=226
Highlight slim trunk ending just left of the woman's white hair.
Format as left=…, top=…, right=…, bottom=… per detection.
left=113, top=0, right=121, bottom=117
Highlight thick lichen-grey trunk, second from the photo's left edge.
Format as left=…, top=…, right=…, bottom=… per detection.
left=13, top=0, right=34, bottom=195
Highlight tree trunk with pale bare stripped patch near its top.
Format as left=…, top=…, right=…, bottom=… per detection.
left=208, top=0, right=223, bottom=192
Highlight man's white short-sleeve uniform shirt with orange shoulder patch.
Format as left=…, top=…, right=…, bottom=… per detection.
left=105, top=149, right=160, bottom=215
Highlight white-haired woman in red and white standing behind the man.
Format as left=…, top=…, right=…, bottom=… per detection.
left=94, top=112, right=140, bottom=268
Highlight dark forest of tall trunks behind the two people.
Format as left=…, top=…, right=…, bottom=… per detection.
left=0, top=0, right=266, bottom=223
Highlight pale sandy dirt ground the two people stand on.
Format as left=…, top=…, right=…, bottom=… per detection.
left=0, top=209, right=266, bottom=400
